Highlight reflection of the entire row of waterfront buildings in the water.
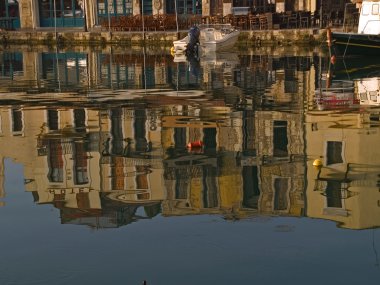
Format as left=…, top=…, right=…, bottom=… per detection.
left=0, top=49, right=380, bottom=229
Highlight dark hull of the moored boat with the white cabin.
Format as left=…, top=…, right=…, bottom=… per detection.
left=331, top=32, right=380, bottom=56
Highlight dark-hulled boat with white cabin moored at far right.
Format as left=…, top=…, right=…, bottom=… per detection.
left=328, top=0, right=380, bottom=57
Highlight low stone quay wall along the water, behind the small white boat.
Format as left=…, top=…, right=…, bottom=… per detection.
left=0, top=28, right=326, bottom=47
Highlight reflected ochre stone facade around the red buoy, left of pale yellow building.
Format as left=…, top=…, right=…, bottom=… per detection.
left=162, top=107, right=305, bottom=219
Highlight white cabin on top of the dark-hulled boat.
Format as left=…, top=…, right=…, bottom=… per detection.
left=358, top=0, right=380, bottom=35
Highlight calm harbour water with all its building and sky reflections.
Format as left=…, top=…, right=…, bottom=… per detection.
left=0, top=48, right=380, bottom=284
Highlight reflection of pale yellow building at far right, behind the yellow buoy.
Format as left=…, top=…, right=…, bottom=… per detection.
left=306, top=100, right=380, bottom=229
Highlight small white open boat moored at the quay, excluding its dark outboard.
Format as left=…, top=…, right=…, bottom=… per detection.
left=173, top=24, right=240, bottom=53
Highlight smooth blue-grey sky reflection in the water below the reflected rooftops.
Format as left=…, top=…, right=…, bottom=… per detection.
left=0, top=160, right=380, bottom=285
